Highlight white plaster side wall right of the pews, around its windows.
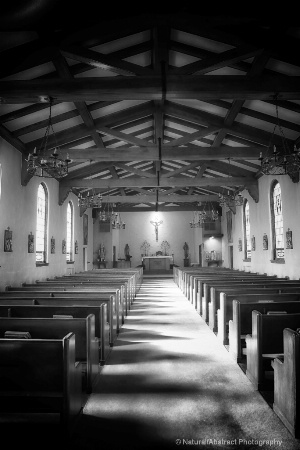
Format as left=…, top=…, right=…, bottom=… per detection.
left=222, top=175, right=300, bottom=279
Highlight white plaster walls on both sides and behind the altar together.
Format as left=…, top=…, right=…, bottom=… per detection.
left=0, top=134, right=300, bottom=284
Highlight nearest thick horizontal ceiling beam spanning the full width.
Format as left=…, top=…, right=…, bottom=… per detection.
left=0, top=75, right=300, bottom=104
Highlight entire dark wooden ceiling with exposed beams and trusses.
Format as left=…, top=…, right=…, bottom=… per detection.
left=0, top=0, right=300, bottom=211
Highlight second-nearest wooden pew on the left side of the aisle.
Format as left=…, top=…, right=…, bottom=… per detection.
left=0, top=314, right=99, bottom=393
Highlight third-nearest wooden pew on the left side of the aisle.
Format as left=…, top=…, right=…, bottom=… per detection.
left=0, top=302, right=110, bottom=364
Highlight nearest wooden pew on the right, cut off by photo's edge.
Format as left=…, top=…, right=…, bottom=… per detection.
left=272, top=328, right=300, bottom=438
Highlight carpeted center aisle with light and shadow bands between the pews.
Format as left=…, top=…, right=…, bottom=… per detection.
left=72, top=278, right=299, bottom=450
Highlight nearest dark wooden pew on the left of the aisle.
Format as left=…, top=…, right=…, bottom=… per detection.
left=0, top=333, right=84, bottom=434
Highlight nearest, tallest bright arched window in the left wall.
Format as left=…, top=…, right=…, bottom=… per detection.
left=35, top=183, right=48, bottom=264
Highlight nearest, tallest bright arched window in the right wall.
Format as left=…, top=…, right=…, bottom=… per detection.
left=270, top=181, right=284, bottom=259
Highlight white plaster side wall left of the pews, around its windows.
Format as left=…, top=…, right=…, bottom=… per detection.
left=0, top=138, right=93, bottom=290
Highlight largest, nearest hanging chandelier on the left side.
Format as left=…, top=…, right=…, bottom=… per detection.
left=26, top=98, right=71, bottom=178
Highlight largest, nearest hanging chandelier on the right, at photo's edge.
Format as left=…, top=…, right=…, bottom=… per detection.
left=258, top=95, right=300, bottom=178
